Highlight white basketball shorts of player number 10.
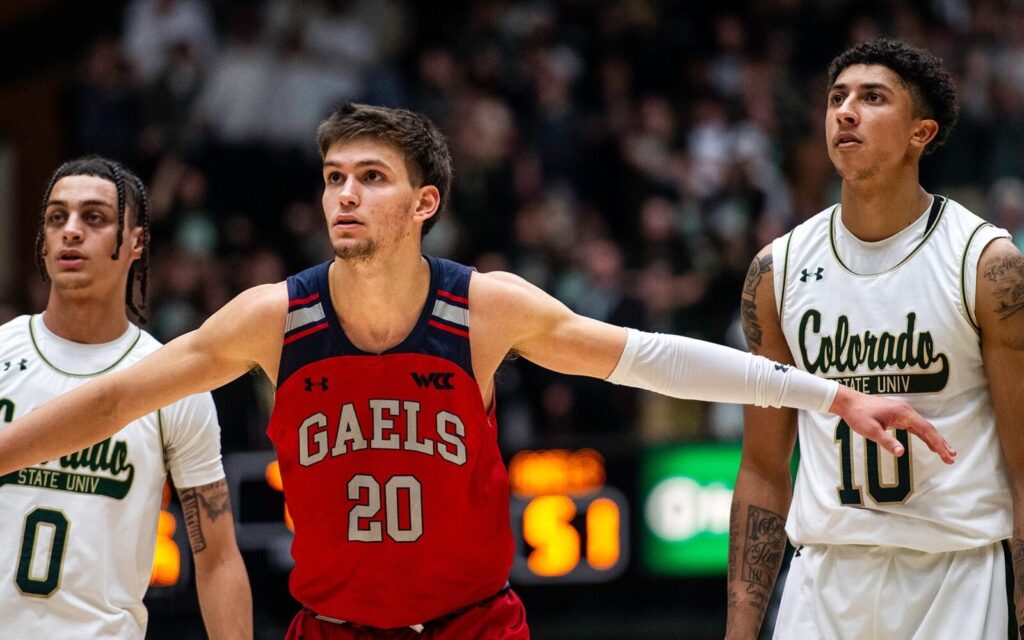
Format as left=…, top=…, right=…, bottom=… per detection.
left=774, top=543, right=1017, bottom=640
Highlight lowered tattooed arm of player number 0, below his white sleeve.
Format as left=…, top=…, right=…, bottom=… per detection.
left=178, top=479, right=253, bottom=640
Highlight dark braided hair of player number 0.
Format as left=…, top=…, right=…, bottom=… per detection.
left=36, top=156, right=150, bottom=325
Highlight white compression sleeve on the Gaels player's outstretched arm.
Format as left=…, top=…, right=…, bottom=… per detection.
left=608, top=329, right=839, bottom=413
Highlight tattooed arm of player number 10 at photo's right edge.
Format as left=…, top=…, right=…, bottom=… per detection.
left=975, top=240, right=1024, bottom=635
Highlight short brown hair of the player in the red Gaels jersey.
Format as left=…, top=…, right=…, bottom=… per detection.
left=316, top=102, right=452, bottom=236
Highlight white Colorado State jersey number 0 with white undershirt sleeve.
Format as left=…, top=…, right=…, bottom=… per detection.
left=0, top=315, right=224, bottom=640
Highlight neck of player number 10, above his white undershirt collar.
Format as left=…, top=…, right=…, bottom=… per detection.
left=841, top=173, right=931, bottom=242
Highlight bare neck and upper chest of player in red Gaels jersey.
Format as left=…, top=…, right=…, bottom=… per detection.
left=329, top=249, right=430, bottom=353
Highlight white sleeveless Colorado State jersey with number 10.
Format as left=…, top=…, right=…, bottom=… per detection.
left=772, top=197, right=1012, bottom=552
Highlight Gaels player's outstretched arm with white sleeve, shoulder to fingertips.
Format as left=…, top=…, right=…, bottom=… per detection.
left=470, top=266, right=955, bottom=463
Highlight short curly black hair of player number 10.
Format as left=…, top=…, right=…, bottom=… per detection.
left=828, top=38, right=959, bottom=154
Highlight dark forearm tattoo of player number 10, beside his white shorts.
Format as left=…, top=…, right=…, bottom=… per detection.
left=740, top=505, right=785, bottom=613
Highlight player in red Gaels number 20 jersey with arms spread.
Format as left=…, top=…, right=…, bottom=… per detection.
left=0, top=104, right=955, bottom=640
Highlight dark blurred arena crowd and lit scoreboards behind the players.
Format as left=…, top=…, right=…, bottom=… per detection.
left=0, top=0, right=1024, bottom=640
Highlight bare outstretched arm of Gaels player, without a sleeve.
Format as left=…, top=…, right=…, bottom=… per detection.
left=0, top=283, right=288, bottom=474
